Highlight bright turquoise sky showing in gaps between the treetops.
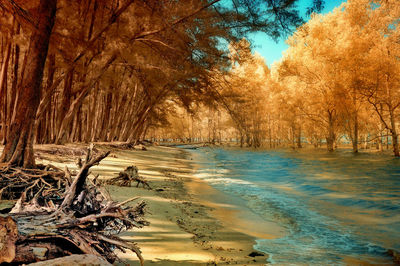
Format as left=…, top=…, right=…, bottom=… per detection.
left=250, top=0, right=347, bottom=66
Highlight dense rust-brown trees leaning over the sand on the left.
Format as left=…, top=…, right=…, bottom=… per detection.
left=0, top=0, right=322, bottom=167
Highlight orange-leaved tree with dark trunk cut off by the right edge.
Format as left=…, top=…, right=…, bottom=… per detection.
left=349, top=0, right=400, bottom=157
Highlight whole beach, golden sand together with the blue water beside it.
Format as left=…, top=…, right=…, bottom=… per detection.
left=0, top=143, right=400, bottom=265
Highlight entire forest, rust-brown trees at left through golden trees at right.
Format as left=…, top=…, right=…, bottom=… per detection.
left=0, top=0, right=400, bottom=168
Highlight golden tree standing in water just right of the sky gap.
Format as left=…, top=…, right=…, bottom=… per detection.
left=279, top=21, right=341, bottom=151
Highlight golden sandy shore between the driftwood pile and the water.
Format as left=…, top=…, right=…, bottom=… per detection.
left=33, top=146, right=284, bottom=265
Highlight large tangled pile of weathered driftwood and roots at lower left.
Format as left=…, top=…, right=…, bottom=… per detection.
left=0, top=146, right=148, bottom=264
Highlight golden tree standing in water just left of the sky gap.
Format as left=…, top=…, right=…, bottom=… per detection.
left=215, top=39, right=269, bottom=148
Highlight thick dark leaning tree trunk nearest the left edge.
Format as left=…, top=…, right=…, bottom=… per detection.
left=0, top=0, right=57, bottom=168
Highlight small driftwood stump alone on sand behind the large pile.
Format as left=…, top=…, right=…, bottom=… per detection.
left=105, top=166, right=151, bottom=189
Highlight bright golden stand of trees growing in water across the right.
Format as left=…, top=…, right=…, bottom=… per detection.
left=152, top=1, right=400, bottom=156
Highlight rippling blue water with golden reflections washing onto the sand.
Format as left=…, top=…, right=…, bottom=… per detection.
left=191, top=148, right=400, bottom=265
